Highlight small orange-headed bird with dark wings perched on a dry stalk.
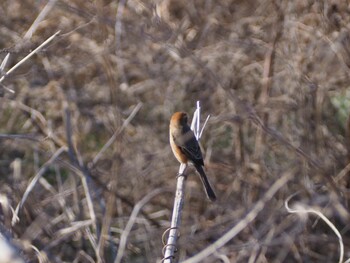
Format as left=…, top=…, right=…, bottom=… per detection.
left=169, top=112, right=216, bottom=201
